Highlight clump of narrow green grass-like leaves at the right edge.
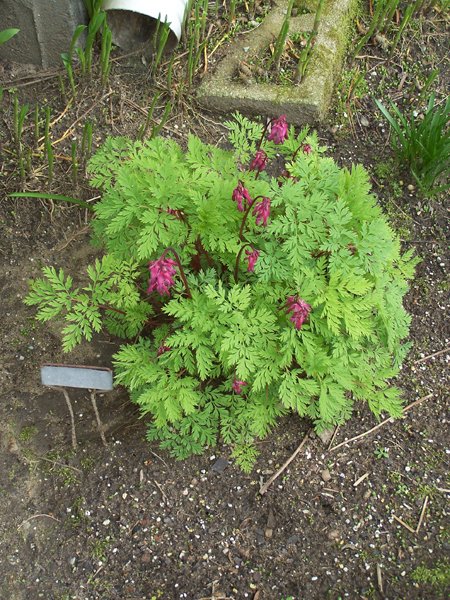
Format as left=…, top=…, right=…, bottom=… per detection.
left=375, top=94, right=450, bottom=196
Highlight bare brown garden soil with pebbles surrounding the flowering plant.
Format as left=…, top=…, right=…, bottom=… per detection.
left=0, top=5, right=450, bottom=600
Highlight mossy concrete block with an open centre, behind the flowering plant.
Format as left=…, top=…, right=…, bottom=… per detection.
left=198, top=0, right=356, bottom=125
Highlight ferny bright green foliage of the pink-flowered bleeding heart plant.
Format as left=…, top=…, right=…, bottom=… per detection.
left=26, top=115, right=417, bottom=470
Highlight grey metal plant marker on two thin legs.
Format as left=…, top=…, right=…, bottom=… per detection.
left=41, top=364, right=113, bottom=450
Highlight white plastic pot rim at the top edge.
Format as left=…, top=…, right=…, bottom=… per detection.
left=103, top=0, right=189, bottom=40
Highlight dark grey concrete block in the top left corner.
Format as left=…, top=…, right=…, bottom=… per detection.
left=0, top=0, right=87, bottom=68
